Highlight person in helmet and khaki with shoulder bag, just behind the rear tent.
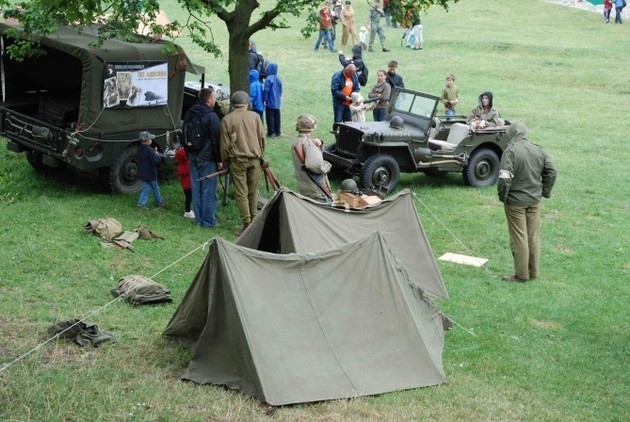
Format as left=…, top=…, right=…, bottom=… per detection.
left=291, top=114, right=332, bottom=202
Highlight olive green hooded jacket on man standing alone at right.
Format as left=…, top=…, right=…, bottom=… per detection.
left=497, top=121, right=556, bottom=206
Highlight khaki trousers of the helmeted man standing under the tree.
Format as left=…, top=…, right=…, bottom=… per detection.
left=230, top=158, right=261, bottom=224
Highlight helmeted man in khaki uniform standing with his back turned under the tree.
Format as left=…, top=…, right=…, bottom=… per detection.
left=221, top=91, right=265, bottom=236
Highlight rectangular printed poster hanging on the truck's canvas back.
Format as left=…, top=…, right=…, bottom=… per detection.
left=103, top=61, right=168, bottom=108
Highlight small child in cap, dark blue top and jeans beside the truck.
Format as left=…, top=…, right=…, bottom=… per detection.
left=136, top=131, right=167, bottom=210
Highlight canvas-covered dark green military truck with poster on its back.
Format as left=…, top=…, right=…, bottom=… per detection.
left=0, top=23, right=209, bottom=193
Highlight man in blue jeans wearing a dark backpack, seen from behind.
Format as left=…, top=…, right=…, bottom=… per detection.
left=182, top=87, right=223, bottom=228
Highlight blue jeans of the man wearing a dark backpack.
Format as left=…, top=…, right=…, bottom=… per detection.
left=188, top=154, right=219, bottom=227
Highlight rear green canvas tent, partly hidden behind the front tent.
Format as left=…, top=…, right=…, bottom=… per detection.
left=236, top=188, right=448, bottom=298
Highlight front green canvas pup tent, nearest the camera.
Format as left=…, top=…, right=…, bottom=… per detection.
left=164, top=232, right=446, bottom=405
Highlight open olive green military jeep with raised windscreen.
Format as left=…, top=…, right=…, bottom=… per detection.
left=324, top=89, right=507, bottom=192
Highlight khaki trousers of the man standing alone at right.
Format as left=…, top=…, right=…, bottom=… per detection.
left=504, top=204, right=540, bottom=280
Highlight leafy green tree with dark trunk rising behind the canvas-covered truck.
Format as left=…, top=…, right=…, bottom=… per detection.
left=0, top=0, right=458, bottom=91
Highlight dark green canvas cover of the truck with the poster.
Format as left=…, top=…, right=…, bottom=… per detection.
left=0, top=23, right=200, bottom=134
